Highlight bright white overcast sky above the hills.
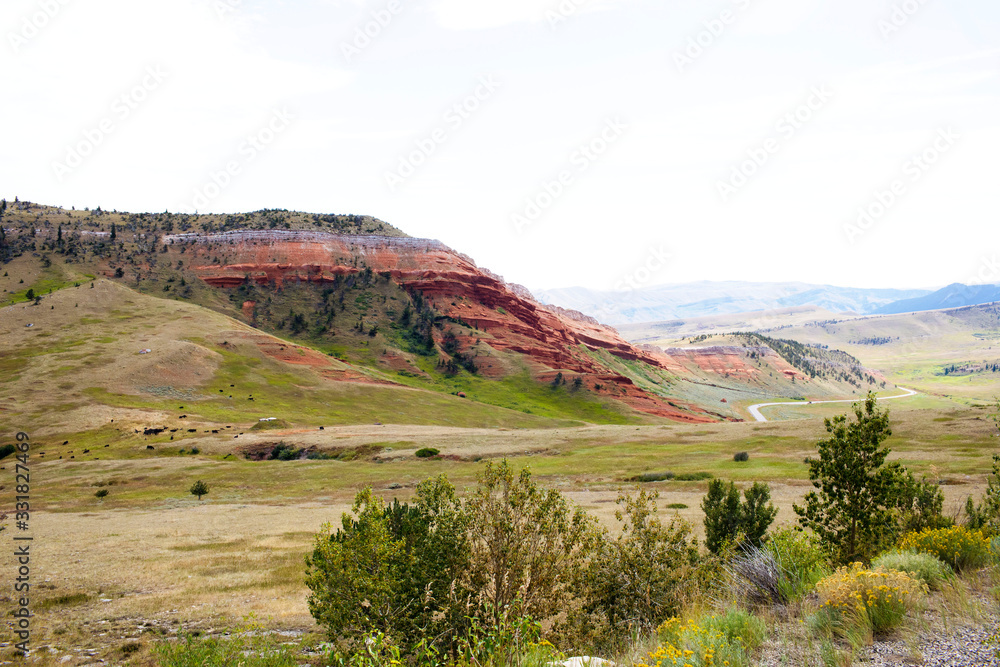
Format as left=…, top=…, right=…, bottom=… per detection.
left=0, top=0, right=1000, bottom=290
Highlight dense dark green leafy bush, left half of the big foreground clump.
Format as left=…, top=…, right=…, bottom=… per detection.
left=306, top=477, right=469, bottom=651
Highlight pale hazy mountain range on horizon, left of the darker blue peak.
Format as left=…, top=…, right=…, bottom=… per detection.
left=533, top=281, right=932, bottom=325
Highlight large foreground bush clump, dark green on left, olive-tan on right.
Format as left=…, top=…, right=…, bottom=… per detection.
left=306, top=460, right=596, bottom=664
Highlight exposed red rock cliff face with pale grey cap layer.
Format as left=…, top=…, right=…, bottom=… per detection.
left=170, top=231, right=718, bottom=422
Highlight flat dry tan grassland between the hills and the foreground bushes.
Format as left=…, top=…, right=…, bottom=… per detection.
left=3, top=407, right=997, bottom=659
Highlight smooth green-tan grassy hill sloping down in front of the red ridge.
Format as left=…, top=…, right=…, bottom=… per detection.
left=0, top=280, right=664, bottom=460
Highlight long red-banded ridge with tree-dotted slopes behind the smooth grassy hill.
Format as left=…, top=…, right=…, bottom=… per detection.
left=0, top=202, right=892, bottom=423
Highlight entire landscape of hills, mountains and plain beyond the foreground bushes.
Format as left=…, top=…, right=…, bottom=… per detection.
left=0, top=202, right=1000, bottom=664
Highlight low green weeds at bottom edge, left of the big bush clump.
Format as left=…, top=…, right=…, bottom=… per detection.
left=153, top=617, right=298, bottom=667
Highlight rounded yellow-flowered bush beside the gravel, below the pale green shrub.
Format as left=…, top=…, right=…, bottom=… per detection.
left=816, top=563, right=927, bottom=635
